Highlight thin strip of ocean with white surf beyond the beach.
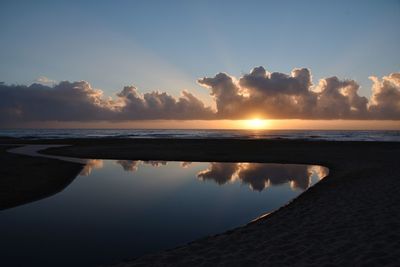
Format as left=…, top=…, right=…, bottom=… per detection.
left=0, top=129, right=400, bottom=142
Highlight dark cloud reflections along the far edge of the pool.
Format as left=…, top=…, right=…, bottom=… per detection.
left=81, top=160, right=328, bottom=191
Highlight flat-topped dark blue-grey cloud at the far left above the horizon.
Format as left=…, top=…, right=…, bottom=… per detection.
left=0, top=81, right=114, bottom=122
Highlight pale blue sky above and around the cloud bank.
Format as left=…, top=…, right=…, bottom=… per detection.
left=0, top=0, right=400, bottom=130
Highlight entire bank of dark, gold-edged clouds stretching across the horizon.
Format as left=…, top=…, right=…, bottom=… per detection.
left=0, top=67, right=400, bottom=125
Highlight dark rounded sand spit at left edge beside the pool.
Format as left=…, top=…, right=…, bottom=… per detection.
left=0, top=145, right=83, bottom=210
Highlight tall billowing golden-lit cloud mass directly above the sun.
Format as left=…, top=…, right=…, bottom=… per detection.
left=198, top=67, right=390, bottom=119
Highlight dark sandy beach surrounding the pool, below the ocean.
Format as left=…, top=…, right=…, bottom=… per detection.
left=0, top=138, right=400, bottom=266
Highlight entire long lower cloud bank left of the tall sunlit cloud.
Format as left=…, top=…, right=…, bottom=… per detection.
left=0, top=81, right=214, bottom=124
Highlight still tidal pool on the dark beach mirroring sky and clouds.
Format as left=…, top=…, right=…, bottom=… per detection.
left=0, top=160, right=328, bottom=266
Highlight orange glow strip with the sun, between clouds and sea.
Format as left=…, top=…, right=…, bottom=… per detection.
left=9, top=118, right=400, bottom=130
